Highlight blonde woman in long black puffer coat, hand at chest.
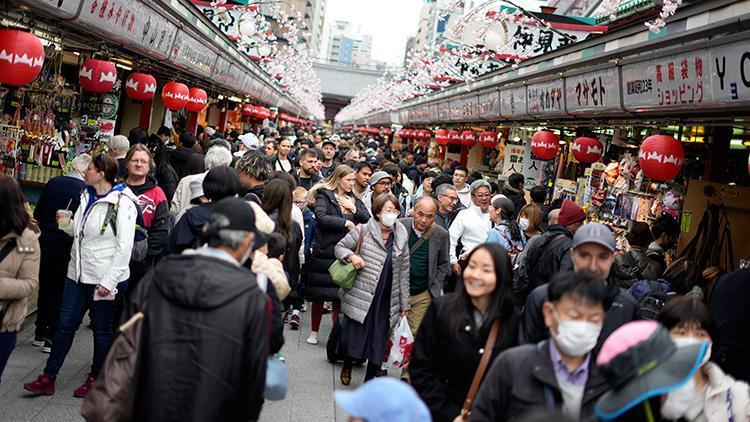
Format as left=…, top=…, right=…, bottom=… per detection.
left=305, top=165, right=370, bottom=344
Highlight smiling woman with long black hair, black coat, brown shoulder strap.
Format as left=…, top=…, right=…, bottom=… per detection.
left=409, top=243, right=518, bottom=422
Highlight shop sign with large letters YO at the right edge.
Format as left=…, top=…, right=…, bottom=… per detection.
left=710, top=40, right=750, bottom=106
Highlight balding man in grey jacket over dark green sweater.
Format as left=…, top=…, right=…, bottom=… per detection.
left=399, top=196, right=451, bottom=379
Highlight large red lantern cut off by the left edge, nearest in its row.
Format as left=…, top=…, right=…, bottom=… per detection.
left=0, top=29, right=44, bottom=86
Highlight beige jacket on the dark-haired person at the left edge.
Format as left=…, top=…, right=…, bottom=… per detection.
left=0, top=229, right=39, bottom=333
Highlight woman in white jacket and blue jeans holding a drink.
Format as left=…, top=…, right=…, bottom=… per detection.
left=24, top=155, right=138, bottom=397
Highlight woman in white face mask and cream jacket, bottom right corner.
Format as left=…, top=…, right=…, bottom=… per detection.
left=658, top=297, right=750, bottom=422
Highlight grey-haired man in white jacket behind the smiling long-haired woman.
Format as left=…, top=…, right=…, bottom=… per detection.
left=449, top=179, right=492, bottom=276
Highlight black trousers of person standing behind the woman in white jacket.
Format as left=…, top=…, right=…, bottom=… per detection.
left=35, top=239, right=73, bottom=339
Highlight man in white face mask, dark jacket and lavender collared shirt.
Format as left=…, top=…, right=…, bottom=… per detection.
left=469, top=272, right=612, bottom=421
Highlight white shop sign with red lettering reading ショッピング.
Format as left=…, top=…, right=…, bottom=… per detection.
left=622, top=50, right=712, bottom=111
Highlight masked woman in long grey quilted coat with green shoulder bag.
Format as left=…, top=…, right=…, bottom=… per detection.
left=336, top=193, right=409, bottom=385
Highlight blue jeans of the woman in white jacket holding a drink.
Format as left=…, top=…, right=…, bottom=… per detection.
left=44, top=279, right=128, bottom=379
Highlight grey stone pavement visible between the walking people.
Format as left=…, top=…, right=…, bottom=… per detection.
left=0, top=307, right=374, bottom=422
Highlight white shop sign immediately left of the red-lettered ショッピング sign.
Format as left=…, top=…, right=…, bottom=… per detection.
left=565, top=68, right=622, bottom=115
